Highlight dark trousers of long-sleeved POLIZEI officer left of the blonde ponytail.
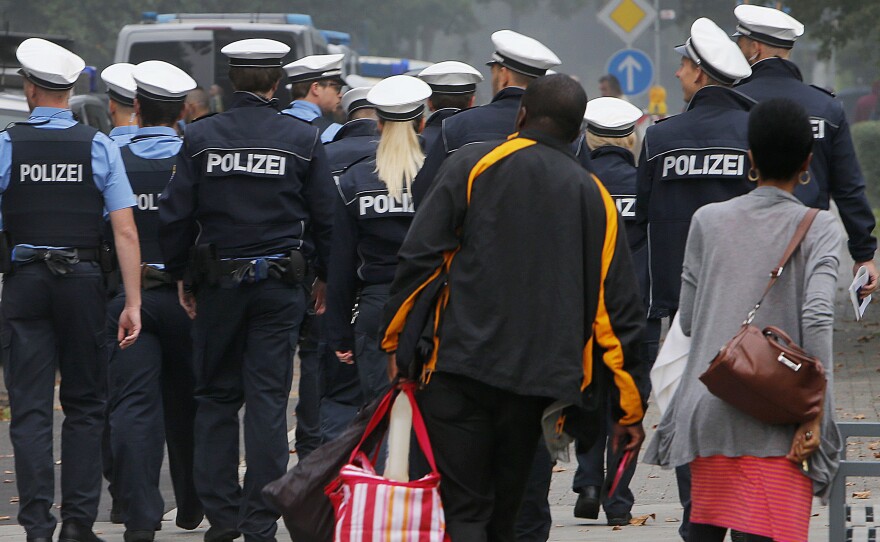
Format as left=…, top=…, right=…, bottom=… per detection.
left=193, top=279, right=306, bottom=541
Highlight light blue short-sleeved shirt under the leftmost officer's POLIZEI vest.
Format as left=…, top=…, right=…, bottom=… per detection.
left=0, top=107, right=135, bottom=235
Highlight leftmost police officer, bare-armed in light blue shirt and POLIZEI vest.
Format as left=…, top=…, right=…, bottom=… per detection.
left=0, top=38, right=141, bottom=542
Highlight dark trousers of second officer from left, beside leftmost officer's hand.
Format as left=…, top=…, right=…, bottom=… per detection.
left=107, top=287, right=202, bottom=531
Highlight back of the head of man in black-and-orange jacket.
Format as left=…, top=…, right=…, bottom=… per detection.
left=517, top=73, right=587, bottom=141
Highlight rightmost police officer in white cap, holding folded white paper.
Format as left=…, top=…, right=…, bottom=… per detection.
left=734, top=5, right=878, bottom=294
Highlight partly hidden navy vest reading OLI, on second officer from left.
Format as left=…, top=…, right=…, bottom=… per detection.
left=121, top=146, right=177, bottom=263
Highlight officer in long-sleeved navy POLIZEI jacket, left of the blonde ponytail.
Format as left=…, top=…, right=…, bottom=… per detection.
left=159, top=39, right=335, bottom=542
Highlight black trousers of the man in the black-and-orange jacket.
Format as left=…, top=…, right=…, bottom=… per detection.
left=417, top=372, right=550, bottom=542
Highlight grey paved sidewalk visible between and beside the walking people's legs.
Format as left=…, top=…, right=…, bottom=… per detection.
left=0, top=253, right=880, bottom=542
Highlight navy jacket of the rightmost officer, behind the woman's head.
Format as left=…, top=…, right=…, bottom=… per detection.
left=736, top=58, right=877, bottom=262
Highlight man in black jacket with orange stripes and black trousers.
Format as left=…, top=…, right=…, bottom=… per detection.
left=382, top=75, right=645, bottom=542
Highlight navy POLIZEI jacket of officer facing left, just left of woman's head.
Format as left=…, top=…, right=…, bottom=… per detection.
left=636, top=86, right=754, bottom=318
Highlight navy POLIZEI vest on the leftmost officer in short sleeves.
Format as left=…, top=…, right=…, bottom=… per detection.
left=0, top=124, right=104, bottom=248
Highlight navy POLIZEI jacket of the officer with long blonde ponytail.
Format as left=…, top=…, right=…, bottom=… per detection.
left=325, top=159, right=415, bottom=350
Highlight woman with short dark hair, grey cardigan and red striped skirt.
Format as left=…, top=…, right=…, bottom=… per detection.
left=646, top=99, right=843, bottom=542
